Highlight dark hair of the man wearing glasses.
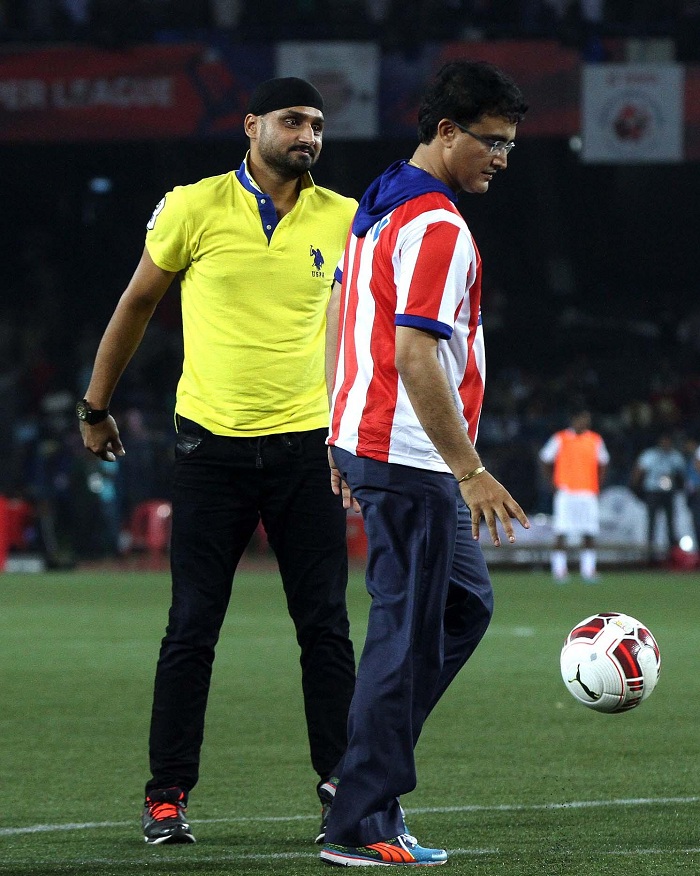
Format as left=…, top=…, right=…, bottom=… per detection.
left=418, top=61, right=527, bottom=143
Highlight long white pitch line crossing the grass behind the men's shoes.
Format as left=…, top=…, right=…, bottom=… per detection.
left=0, top=797, right=700, bottom=840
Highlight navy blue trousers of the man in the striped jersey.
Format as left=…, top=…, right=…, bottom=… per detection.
left=326, top=448, right=493, bottom=846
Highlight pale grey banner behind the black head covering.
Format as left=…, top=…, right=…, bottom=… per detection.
left=275, top=40, right=380, bottom=140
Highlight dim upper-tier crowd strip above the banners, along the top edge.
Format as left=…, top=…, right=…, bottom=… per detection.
left=0, top=0, right=700, bottom=60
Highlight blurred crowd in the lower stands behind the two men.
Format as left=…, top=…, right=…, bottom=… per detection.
left=5, top=186, right=700, bottom=562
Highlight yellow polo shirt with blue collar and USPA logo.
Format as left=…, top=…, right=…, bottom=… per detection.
left=146, top=161, right=357, bottom=437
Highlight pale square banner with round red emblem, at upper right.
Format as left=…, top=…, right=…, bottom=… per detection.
left=581, top=63, right=685, bottom=164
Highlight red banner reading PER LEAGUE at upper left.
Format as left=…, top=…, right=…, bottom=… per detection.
left=0, top=43, right=274, bottom=142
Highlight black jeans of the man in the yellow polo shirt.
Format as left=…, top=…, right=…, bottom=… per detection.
left=146, top=418, right=355, bottom=793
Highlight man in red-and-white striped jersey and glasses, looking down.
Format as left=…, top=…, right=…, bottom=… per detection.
left=321, top=61, right=529, bottom=866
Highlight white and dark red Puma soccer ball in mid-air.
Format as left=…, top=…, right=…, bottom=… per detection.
left=560, top=611, right=661, bottom=713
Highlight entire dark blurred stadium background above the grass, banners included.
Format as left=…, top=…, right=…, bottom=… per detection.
left=0, top=0, right=700, bottom=568
